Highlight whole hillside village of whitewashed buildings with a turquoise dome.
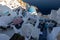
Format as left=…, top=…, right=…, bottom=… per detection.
left=0, top=0, right=60, bottom=40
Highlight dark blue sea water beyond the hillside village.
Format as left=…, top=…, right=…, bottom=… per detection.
left=23, top=0, right=60, bottom=15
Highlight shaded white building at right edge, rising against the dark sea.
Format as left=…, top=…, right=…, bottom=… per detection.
left=48, top=9, right=60, bottom=24
